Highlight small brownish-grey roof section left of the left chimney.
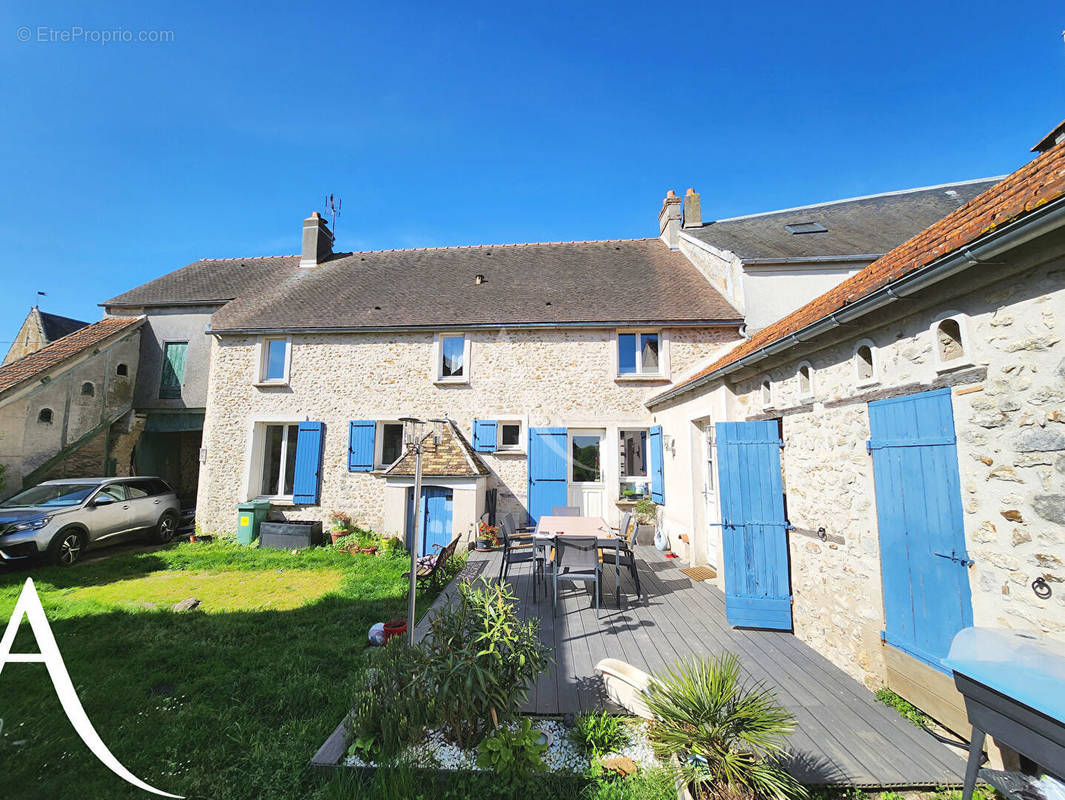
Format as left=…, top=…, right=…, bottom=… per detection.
left=100, top=256, right=299, bottom=307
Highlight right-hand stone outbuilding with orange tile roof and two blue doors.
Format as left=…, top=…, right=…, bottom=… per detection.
left=646, top=128, right=1065, bottom=732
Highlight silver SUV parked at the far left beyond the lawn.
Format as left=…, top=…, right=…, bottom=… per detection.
left=0, top=477, right=181, bottom=566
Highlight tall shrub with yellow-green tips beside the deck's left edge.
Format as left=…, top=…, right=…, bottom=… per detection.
left=426, top=578, right=550, bottom=747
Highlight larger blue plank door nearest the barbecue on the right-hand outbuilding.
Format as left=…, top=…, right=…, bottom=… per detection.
left=869, top=389, right=972, bottom=671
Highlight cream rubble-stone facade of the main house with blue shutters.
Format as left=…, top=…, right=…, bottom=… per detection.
left=197, top=328, right=735, bottom=533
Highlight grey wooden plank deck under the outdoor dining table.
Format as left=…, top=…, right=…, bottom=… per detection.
left=415, top=548, right=965, bottom=787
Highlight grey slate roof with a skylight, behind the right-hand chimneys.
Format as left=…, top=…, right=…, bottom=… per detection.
left=685, top=178, right=1000, bottom=260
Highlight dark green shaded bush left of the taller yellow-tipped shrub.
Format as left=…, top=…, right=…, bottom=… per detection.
left=348, top=636, right=435, bottom=760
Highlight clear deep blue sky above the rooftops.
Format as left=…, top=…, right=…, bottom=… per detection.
left=0, top=0, right=1065, bottom=349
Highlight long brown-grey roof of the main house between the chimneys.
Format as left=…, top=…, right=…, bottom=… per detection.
left=205, top=239, right=740, bottom=331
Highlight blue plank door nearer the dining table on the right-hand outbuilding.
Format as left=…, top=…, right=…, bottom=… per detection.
left=717, top=420, right=791, bottom=631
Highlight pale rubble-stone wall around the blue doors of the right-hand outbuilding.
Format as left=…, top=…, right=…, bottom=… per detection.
left=730, top=250, right=1065, bottom=686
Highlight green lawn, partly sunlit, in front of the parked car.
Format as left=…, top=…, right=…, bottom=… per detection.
left=0, top=543, right=440, bottom=800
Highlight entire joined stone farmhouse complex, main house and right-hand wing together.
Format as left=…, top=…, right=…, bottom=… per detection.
left=0, top=117, right=1065, bottom=749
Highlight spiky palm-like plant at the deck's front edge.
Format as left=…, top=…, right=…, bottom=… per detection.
left=646, top=653, right=806, bottom=800
